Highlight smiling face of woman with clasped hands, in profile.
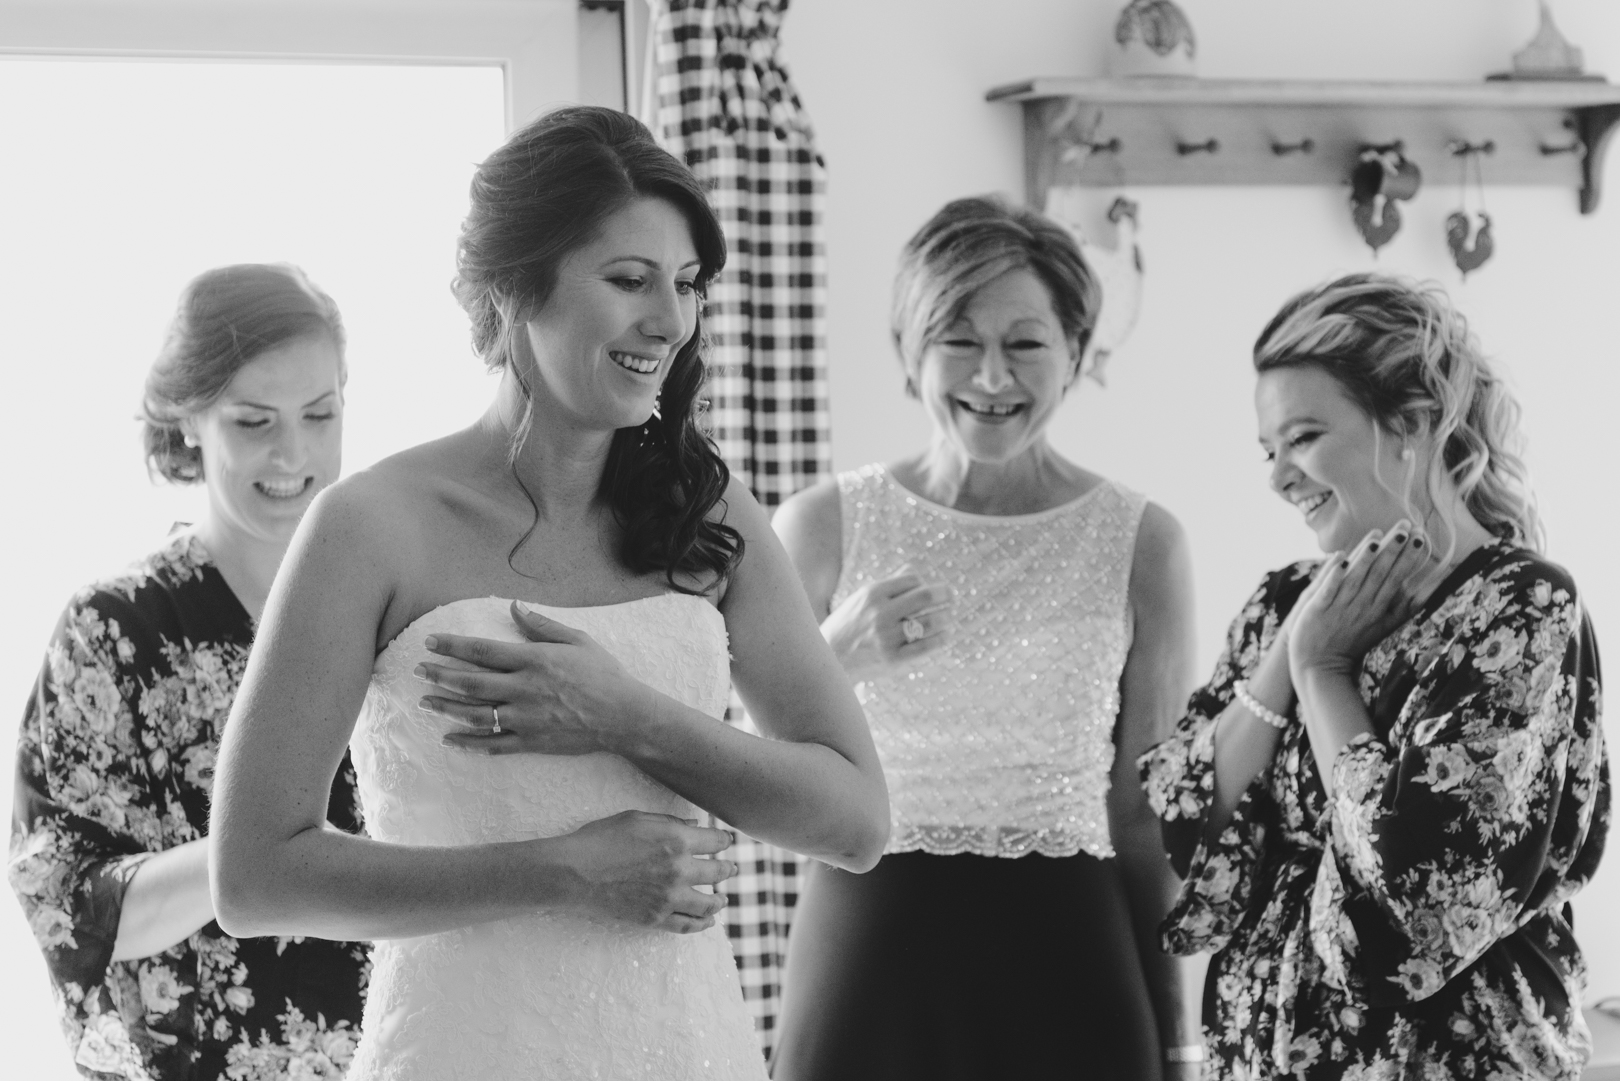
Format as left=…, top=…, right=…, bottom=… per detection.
left=1254, top=365, right=1422, bottom=551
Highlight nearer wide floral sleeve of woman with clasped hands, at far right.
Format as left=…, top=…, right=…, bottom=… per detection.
left=1311, top=559, right=1609, bottom=1005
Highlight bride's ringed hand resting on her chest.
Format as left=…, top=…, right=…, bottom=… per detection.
left=416, top=601, right=659, bottom=755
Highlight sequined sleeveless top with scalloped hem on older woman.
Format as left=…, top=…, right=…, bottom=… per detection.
left=833, top=465, right=1147, bottom=857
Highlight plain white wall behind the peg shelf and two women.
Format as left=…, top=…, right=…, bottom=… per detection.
left=782, top=0, right=1620, bottom=997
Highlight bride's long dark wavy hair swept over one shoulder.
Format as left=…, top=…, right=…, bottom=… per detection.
left=452, top=105, right=744, bottom=593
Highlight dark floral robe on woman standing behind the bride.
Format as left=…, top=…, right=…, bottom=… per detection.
left=8, top=535, right=369, bottom=1081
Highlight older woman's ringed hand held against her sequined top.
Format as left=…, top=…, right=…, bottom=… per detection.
left=821, top=569, right=956, bottom=682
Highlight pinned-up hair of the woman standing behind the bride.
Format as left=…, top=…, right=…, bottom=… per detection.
left=141, top=263, right=347, bottom=485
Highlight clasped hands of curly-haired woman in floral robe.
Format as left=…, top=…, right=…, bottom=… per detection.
left=1288, top=519, right=1434, bottom=687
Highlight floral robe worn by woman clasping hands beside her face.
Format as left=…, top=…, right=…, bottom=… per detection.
left=1139, top=543, right=1609, bottom=1081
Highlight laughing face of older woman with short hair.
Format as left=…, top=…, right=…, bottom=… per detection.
left=917, top=269, right=1076, bottom=464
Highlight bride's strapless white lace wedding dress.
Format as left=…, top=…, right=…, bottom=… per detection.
left=348, top=593, right=765, bottom=1081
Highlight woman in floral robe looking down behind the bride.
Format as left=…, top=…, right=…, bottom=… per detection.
left=8, top=266, right=369, bottom=1081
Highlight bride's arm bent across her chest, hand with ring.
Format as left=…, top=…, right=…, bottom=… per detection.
left=421, top=483, right=889, bottom=870
